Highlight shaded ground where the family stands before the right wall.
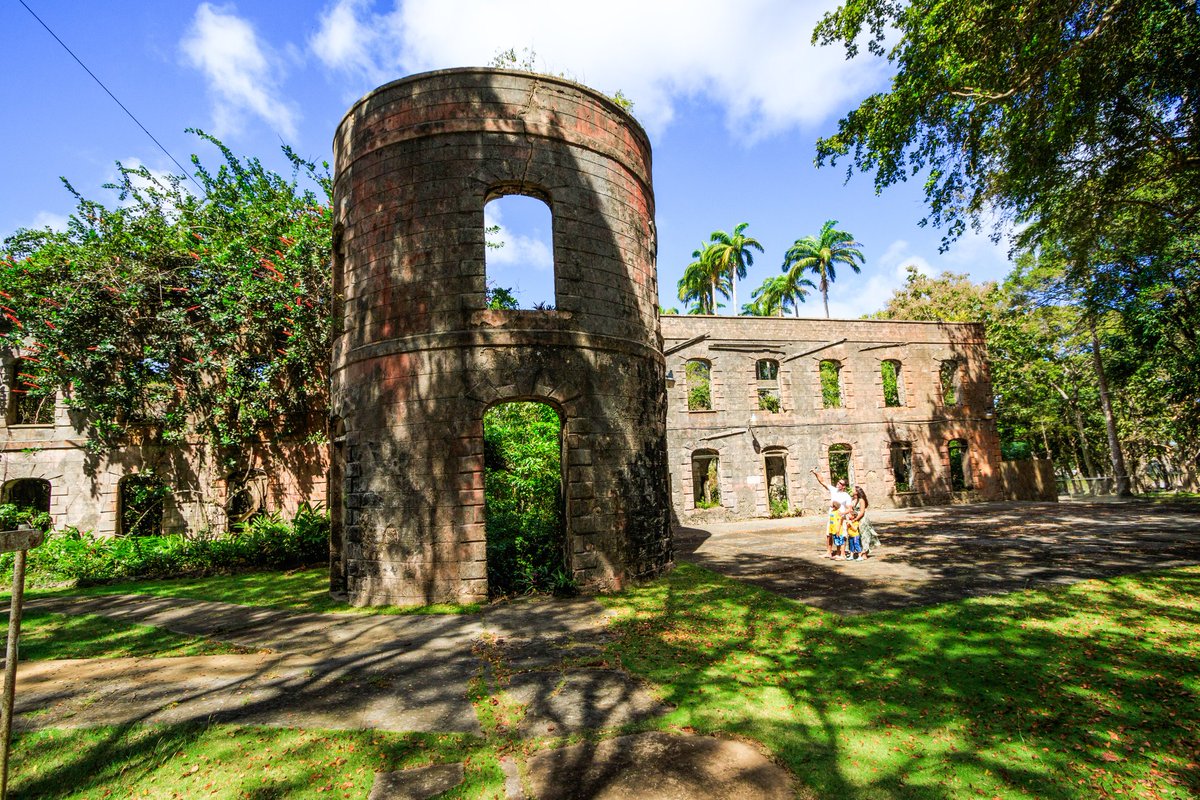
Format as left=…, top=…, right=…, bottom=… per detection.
left=676, top=500, right=1200, bottom=614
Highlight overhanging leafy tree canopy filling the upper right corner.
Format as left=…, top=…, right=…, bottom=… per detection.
left=814, top=0, right=1200, bottom=257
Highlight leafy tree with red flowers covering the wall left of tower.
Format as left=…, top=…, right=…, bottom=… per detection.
left=0, top=132, right=332, bottom=455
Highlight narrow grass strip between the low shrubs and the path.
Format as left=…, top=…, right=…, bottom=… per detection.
left=7, top=567, right=480, bottom=614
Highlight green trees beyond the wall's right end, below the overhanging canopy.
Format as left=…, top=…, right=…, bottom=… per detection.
left=876, top=263, right=1200, bottom=483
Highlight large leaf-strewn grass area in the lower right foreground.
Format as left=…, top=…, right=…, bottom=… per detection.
left=602, top=565, right=1200, bottom=799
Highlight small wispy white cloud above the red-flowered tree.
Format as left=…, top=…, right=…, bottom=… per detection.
left=180, top=2, right=296, bottom=139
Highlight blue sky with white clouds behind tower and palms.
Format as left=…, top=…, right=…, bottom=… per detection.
left=0, top=0, right=1008, bottom=317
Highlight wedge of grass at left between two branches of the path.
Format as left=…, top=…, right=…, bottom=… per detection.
left=5, top=609, right=252, bottom=661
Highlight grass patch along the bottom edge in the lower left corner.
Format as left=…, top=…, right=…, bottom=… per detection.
left=10, top=724, right=487, bottom=799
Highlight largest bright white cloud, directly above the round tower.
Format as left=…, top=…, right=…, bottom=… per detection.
left=310, top=0, right=887, bottom=142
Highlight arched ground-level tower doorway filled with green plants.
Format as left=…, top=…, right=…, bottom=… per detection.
left=484, top=401, right=574, bottom=597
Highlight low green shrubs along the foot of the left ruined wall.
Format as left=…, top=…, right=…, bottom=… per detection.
left=0, top=504, right=329, bottom=585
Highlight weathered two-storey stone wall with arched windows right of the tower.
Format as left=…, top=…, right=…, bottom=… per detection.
left=661, top=315, right=1003, bottom=518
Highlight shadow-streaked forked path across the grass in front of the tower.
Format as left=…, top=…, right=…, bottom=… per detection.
left=17, top=595, right=661, bottom=733
